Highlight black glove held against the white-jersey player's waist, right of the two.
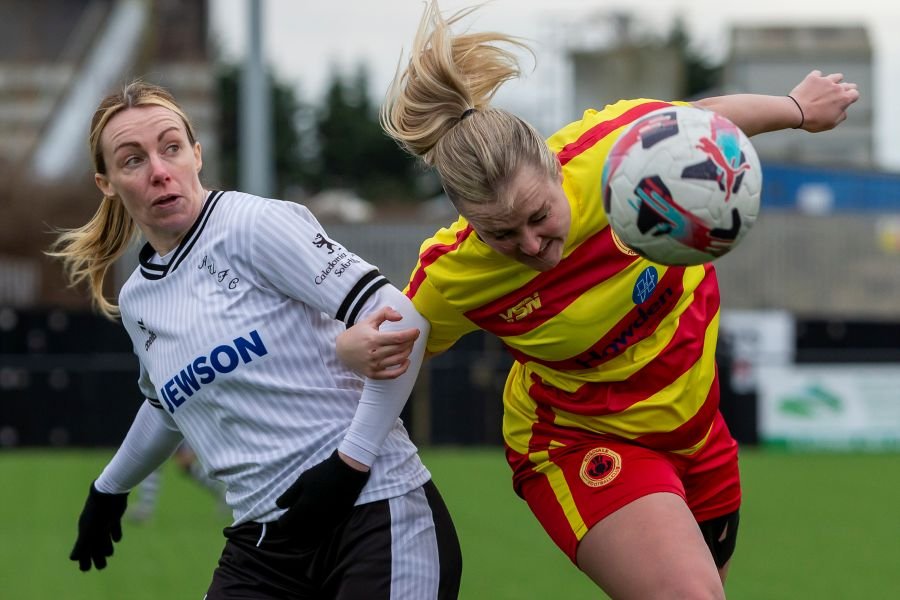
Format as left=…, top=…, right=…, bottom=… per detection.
left=275, top=450, right=369, bottom=543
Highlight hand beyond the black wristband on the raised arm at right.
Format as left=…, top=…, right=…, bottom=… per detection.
left=790, top=70, right=859, bottom=132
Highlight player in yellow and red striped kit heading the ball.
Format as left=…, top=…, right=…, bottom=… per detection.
left=338, top=1, right=859, bottom=600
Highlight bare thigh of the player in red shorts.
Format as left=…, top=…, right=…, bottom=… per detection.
left=578, top=493, right=725, bottom=600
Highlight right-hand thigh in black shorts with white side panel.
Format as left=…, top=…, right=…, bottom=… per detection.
left=324, top=482, right=462, bottom=600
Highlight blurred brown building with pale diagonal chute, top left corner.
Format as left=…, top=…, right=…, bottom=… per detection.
left=0, top=0, right=216, bottom=181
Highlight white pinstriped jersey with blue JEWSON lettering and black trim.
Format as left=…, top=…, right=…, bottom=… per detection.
left=119, top=192, right=430, bottom=523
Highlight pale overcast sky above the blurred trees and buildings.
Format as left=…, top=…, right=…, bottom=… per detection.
left=210, top=0, right=900, bottom=170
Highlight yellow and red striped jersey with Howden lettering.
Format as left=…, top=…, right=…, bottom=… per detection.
left=406, top=100, right=719, bottom=455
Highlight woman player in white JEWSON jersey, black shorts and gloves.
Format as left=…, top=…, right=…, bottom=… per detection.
left=51, top=81, right=461, bottom=600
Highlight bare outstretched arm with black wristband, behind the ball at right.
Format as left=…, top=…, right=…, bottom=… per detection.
left=693, top=70, right=859, bottom=136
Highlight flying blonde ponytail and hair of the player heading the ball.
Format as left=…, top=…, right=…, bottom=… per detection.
left=381, top=0, right=559, bottom=209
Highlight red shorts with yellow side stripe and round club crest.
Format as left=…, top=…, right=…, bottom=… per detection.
left=515, top=414, right=741, bottom=562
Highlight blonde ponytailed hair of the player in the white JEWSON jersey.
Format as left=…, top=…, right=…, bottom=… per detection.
left=47, top=81, right=197, bottom=319
